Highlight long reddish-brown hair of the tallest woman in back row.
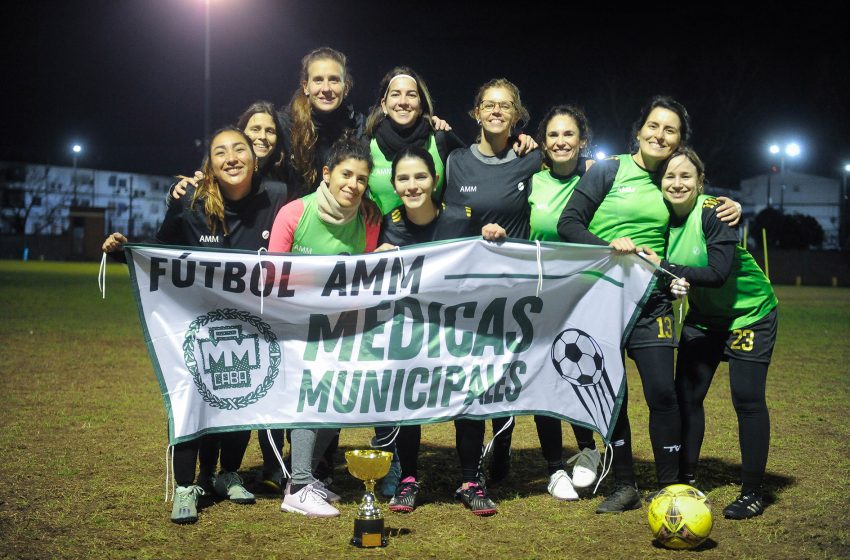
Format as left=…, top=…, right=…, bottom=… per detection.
left=289, top=47, right=354, bottom=189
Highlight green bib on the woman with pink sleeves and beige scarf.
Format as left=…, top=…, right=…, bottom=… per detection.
left=290, top=193, right=366, bottom=255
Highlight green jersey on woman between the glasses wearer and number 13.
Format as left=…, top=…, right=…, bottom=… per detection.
left=528, top=169, right=581, bottom=241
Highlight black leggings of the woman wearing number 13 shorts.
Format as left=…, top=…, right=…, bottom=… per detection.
left=612, top=346, right=682, bottom=486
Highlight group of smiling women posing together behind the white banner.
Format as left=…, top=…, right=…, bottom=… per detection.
left=99, top=47, right=776, bottom=523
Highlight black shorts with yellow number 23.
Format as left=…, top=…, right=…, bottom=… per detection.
left=682, top=309, right=778, bottom=364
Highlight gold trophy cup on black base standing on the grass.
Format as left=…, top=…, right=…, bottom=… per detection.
left=345, top=449, right=393, bottom=548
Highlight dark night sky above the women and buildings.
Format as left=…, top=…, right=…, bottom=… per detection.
left=6, top=0, right=850, bottom=186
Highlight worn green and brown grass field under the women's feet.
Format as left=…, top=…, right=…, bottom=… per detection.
left=0, top=261, right=850, bottom=559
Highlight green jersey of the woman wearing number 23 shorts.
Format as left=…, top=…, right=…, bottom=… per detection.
left=667, top=195, right=778, bottom=330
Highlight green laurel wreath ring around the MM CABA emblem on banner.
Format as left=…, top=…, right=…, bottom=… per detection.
left=183, top=309, right=281, bottom=410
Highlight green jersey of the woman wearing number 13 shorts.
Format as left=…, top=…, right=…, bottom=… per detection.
left=587, top=154, right=670, bottom=258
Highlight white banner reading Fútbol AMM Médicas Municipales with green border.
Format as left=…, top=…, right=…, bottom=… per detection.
left=127, top=239, right=653, bottom=443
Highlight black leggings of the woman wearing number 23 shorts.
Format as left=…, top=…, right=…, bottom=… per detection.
left=676, top=341, right=770, bottom=493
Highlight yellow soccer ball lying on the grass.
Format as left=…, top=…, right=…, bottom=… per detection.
left=648, top=484, right=714, bottom=549
